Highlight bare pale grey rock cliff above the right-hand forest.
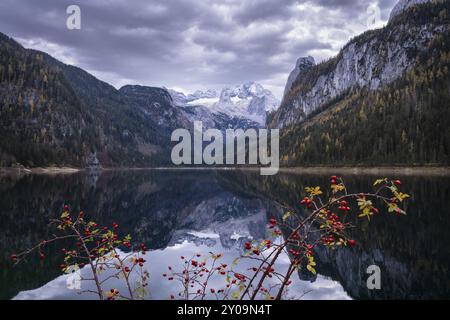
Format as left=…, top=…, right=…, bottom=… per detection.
left=271, top=1, right=449, bottom=128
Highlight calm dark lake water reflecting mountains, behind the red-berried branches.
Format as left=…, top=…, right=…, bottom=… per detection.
left=0, top=171, right=450, bottom=299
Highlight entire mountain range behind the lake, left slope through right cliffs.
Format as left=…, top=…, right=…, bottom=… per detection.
left=0, top=0, right=450, bottom=167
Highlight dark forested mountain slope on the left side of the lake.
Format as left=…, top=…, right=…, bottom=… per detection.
left=0, top=34, right=182, bottom=167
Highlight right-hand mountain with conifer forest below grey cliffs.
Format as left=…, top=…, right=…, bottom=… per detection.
left=270, top=1, right=450, bottom=165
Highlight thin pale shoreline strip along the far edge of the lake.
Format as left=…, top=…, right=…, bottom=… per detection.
left=0, top=165, right=450, bottom=176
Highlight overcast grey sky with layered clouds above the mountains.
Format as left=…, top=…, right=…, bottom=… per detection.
left=0, top=0, right=396, bottom=98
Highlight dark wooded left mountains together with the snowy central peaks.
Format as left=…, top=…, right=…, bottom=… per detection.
left=0, top=34, right=279, bottom=167
